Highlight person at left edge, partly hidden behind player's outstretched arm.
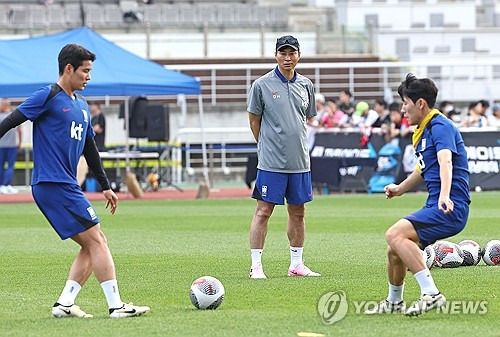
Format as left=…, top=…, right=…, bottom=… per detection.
left=0, top=98, right=23, bottom=194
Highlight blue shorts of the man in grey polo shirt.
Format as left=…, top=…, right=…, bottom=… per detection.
left=252, top=170, right=312, bottom=205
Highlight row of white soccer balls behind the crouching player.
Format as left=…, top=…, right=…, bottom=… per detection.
left=422, top=240, right=500, bottom=269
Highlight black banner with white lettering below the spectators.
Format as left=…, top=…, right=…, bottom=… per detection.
left=246, top=131, right=500, bottom=192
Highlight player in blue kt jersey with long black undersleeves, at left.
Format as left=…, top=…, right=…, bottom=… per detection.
left=0, top=44, right=149, bottom=318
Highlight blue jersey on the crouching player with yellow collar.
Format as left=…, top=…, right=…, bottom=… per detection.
left=416, top=115, right=470, bottom=205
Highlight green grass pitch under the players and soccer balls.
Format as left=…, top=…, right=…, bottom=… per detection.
left=0, top=193, right=500, bottom=337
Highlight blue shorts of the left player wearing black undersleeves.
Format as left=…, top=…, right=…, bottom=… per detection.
left=32, top=183, right=99, bottom=240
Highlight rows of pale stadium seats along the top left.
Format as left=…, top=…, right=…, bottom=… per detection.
left=0, top=0, right=288, bottom=30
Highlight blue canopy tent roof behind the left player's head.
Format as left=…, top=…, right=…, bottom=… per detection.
left=0, top=27, right=200, bottom=97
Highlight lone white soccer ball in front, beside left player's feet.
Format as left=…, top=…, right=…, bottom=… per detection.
left=189, top=276, right=224, bottom=310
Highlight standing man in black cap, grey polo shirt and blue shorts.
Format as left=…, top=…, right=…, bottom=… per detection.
left=247, top=35, right=320, bottom=279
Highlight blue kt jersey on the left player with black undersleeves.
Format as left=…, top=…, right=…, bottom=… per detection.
left=18, top=84, right=95, bottom=185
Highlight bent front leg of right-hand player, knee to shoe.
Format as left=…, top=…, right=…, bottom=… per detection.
left=385, top=219, right=446, bottom=315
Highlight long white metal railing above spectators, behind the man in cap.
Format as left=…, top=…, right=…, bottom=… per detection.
left=172, top=60, right=500, bottom=105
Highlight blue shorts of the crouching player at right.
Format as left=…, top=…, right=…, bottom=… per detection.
left=405, top=203, right=469, bottom=249
